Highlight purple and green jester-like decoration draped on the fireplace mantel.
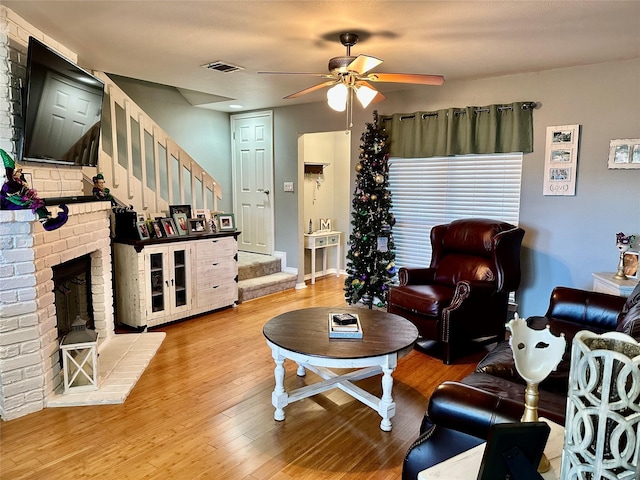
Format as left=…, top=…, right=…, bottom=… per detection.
left=0, top=148, right=69, bottom=231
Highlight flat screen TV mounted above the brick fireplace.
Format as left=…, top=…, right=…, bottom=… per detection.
left=22, top=37, right=104, bottom=167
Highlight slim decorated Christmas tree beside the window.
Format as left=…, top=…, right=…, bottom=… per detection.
left=345, top=112, right=396, bottom=308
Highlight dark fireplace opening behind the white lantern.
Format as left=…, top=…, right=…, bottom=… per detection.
left=53, top=255, right=94, bottom=340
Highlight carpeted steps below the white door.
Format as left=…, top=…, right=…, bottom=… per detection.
left=238, top=252, right=296, bottom=303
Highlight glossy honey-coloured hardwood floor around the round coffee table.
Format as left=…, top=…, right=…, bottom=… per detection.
left=0, top=276, right=481, bottom=480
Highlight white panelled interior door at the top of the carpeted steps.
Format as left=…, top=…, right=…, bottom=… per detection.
left=231, top=112, right=274, bottom=254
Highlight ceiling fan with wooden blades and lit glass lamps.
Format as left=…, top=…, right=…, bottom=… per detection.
left=258, top=33, right=444, bottom=112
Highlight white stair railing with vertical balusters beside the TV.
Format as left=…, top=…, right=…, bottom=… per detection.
left=94, top=72, right=222, bottom=216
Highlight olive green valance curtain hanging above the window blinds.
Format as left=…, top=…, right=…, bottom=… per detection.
left=380, top=102, right=536, bottom=158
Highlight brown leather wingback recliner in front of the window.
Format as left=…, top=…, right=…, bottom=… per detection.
left=387, top=218, right=524, bottom=364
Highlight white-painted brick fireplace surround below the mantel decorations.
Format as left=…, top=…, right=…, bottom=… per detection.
left=0, top=202, right=114, bottom=420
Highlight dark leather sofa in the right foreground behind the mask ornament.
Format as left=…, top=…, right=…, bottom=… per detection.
left=402, top=284, right=640, bottom=480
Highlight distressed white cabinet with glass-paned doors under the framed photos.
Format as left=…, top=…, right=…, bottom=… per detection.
left=114, top=232, right=238, bottom=328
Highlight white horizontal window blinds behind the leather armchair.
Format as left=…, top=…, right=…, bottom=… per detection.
left=389, top=153, right=522, bottom=267
